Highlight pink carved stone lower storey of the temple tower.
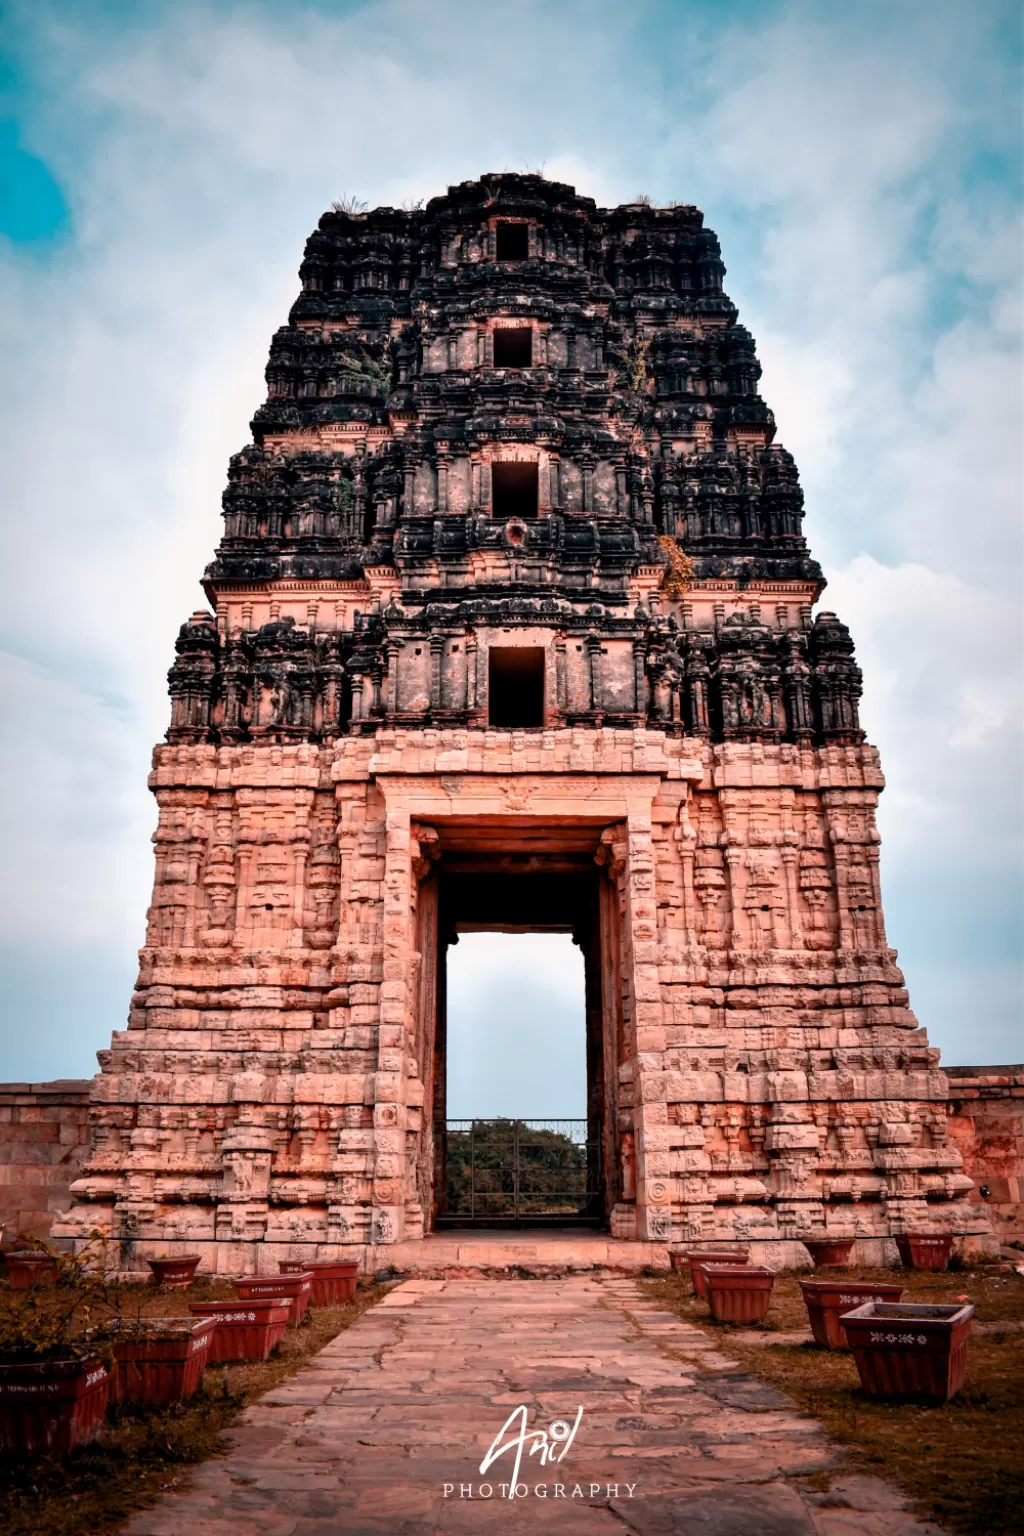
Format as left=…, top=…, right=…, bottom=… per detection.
left=46, top=728, right=995, bottom=1272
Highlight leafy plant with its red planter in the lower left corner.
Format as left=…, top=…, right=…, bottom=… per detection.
left=0, top=1233, right=111, bottom=1456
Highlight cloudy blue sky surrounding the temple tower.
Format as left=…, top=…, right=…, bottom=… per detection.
left=0, top=0, right=1024, bottom=1080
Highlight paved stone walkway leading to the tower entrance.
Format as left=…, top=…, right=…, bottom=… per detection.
left=124, top=1276, right=941, bottom=1536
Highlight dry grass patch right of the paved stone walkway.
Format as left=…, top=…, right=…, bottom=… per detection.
left=646, top=1269, right=1024, bottom=1536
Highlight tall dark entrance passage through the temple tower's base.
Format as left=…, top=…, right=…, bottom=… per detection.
left=419, top=823, right=620, bottom=1230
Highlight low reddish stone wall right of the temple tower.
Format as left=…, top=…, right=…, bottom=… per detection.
left=946, top=1066, right=1024, bottom=1243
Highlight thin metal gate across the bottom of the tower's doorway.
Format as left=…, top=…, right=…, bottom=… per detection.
left=438, top=1120, right=603, bottom=1227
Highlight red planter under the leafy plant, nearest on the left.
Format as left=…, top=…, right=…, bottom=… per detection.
left=0, top=1359, right=111, bottom=1456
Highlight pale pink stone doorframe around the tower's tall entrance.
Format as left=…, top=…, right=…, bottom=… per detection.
left=372, top=773, right=671, bottom=1241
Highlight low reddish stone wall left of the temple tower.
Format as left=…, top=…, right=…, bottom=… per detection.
left=0, top=1080, right=89, bottom=1247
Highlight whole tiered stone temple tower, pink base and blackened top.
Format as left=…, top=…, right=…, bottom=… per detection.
left=57, top=175, right=989, bottom=1272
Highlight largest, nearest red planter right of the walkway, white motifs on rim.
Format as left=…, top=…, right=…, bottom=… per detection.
left=841, top=1301, right=975, bottom=1402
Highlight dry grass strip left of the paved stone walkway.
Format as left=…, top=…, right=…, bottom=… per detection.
left=0, top=1281, right=388, bottom=1536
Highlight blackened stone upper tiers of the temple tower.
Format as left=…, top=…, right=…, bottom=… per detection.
left=169, top=174, right=861, bottom=742
